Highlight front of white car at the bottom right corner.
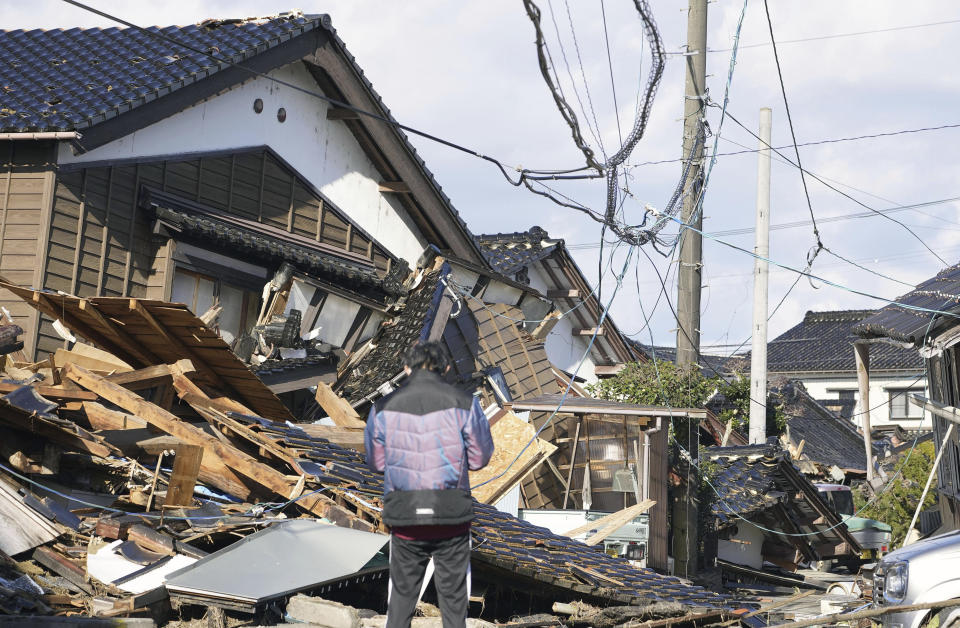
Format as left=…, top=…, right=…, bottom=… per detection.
left=873, top=530, right=960, bottom=628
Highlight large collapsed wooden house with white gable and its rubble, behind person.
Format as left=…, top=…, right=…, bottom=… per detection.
left=0, top=12, right=752, bottom=621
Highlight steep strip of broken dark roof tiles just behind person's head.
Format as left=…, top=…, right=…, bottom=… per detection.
left=340, top=263, right=450, bottom=402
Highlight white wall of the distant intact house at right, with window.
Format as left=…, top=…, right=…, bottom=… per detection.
left=791, top=372, right=933, bottom=429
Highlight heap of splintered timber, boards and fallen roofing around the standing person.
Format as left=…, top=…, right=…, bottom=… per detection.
left=0, top=285, right=730, bottom=623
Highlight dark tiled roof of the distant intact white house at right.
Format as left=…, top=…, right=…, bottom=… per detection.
left=745, top=310, right=923, bottom=373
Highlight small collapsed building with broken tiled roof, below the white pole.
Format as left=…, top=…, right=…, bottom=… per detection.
left=706, top=445, right=861, bottom=579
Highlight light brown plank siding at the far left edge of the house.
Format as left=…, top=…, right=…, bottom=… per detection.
left=0, top=141, right=56, bottom=355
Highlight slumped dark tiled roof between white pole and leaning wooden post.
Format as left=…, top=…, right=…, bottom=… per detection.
left=770, top=381, right=867, bottom=472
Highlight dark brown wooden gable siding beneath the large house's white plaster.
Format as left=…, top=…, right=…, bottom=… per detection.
left=31, top=149, right=390, bottom=357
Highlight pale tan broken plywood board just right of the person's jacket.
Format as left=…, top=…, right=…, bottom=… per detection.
left=470, top=412, right=557, bottom=504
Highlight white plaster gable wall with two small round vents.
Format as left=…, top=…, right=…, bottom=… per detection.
left=59, top=62, right=427, bottom=266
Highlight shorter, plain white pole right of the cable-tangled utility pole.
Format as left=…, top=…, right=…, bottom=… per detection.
left=750, top=107, right=772, bottom=445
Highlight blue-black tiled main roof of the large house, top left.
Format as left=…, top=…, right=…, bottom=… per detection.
left=0, top=15, right=320, bottom=132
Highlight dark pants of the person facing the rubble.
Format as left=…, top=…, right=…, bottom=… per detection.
left=387, top=532, right=470, bottom=628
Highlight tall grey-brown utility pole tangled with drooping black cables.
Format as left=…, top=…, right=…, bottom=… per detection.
left=673, top=0, right=707, bottom=577
